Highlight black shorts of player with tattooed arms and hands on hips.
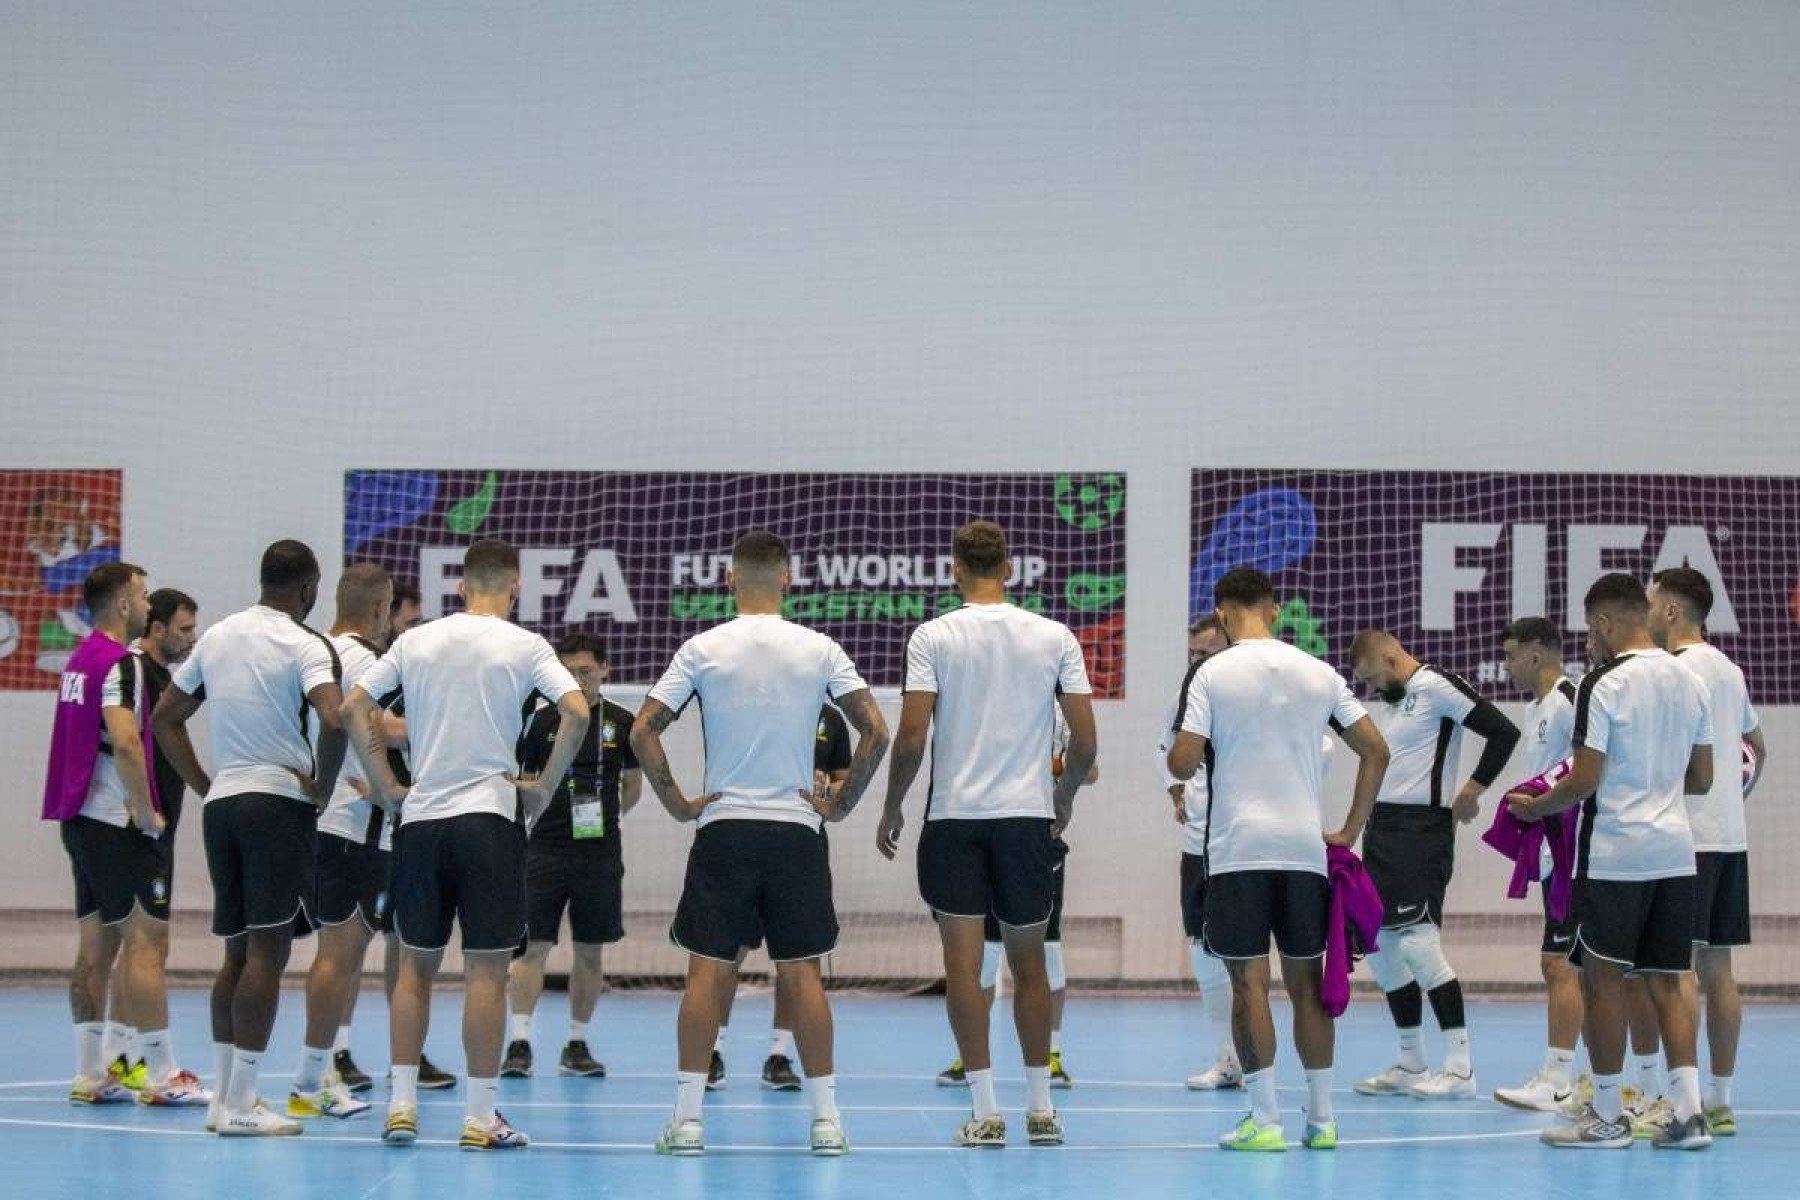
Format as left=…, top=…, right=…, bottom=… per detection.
left=670, top=819, right=837, bottom=963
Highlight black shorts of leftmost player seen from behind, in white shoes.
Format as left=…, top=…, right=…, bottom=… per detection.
left=200, top=792, right=319, bottom=937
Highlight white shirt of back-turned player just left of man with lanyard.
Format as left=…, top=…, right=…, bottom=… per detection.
left=356, top=612, right=580, bottom=826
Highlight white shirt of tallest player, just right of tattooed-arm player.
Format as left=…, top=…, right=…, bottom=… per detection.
left=905, top=603, right=1093, bottom=820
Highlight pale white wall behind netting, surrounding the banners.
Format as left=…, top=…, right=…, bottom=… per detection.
left=0, top=0, right=1800, bottom=975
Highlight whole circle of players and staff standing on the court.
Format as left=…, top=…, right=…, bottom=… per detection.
left=45, top=522, right=1762, bottom=1155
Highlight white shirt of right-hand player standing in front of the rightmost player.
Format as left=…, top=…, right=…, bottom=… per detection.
left=1573, top=649, right=1714, bottom=880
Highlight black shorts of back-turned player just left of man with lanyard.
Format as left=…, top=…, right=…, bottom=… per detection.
left=391, top=813, right=526, bottom=954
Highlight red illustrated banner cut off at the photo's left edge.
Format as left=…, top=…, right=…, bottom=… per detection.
left=0, top=470, right=123, bottom=691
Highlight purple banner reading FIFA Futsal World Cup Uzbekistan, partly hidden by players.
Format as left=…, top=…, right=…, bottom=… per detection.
left=344, top=470, right=1125, bottom=696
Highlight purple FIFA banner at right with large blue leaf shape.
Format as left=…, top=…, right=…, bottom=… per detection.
left=1188, top=470, right=1800, bottom=703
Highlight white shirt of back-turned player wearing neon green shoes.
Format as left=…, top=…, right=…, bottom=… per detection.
left=1181, top=637, right=1368, bottom=874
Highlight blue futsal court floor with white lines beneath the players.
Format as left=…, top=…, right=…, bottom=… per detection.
left=0, top=988, right=1800, bottom=1200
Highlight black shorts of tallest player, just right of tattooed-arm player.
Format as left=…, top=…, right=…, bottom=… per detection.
left=918, top=817, right=1062, bottom=928
